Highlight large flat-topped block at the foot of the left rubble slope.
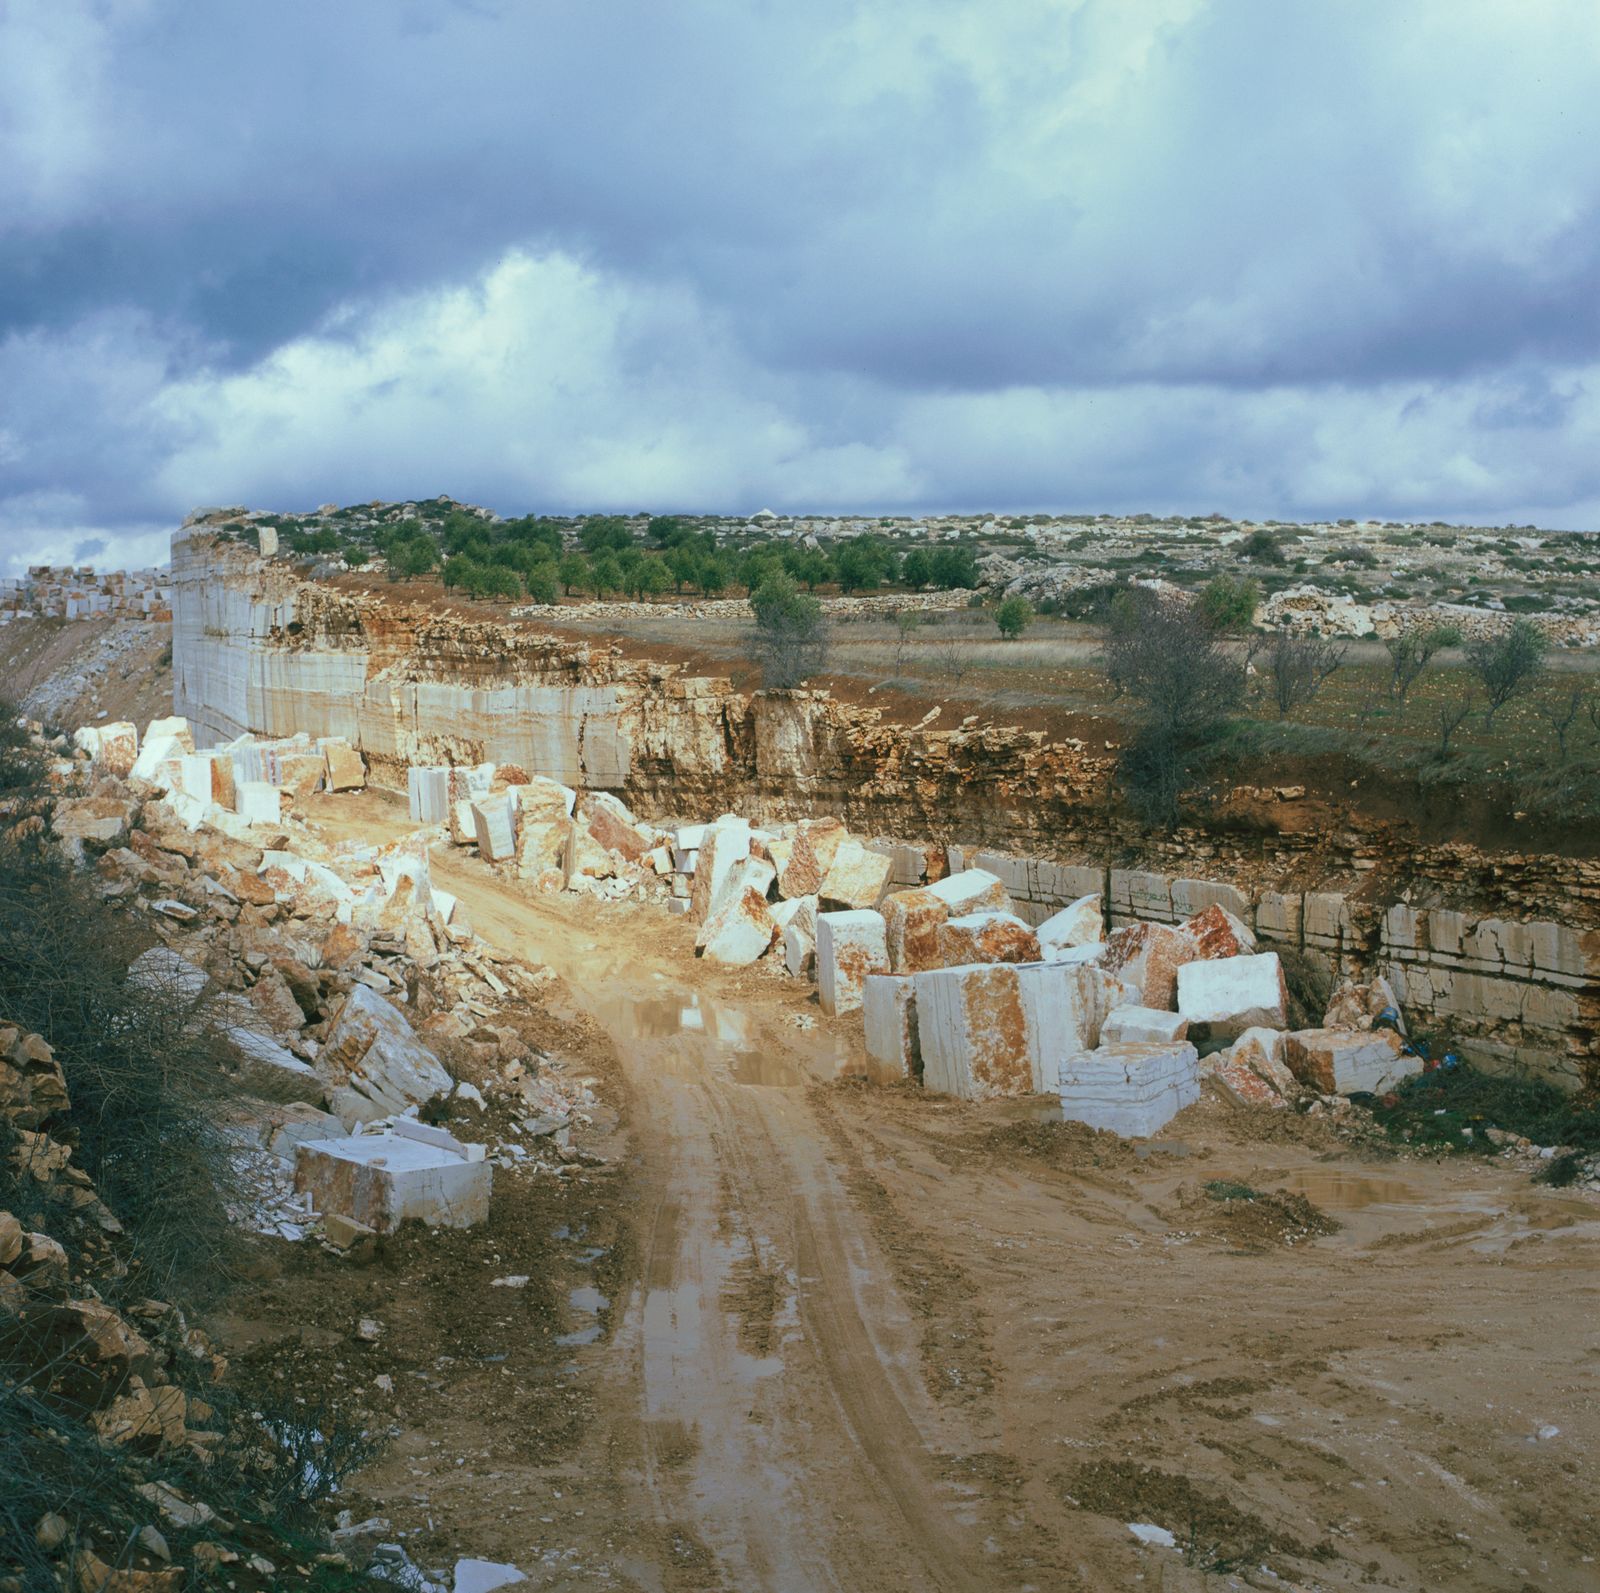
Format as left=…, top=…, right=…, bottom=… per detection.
left=294, top=1134, right=494, bottom=1233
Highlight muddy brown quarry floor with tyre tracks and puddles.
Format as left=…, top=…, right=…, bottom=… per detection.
left=281, top=793, right=1600, bottom=1593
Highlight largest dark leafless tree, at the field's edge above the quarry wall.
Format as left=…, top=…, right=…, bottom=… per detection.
left=1101, top=587, right=1245, bottom=824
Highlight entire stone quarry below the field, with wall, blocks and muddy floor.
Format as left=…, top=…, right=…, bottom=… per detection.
left=0, top=505, right=1600, bottom=1593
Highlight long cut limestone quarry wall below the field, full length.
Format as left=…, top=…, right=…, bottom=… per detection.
left=173, top=531, right=1600, bottom=1081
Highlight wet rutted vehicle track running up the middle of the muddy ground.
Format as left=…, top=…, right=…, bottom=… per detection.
left=419, top=838, right=992, bottom=1593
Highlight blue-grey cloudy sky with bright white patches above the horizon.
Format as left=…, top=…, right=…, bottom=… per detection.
left=0, top=0, right=1600, bottom=568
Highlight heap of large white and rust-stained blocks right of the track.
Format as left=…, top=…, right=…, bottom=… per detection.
left=643, top=808, right=1421, bottom=1134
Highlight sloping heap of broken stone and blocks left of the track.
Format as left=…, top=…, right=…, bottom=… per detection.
left=62, top=718, right=601, bottom=1249
